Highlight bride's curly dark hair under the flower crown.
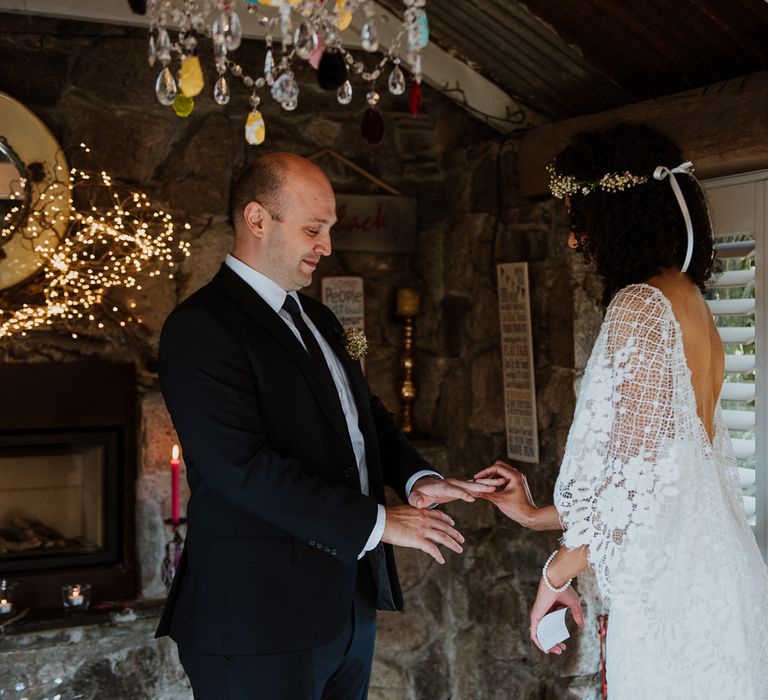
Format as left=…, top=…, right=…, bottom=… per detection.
left=554, top=124, right=714, bottom=306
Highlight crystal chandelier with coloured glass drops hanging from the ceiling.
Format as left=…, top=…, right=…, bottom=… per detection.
left=146, top=0, right=429, bottom=145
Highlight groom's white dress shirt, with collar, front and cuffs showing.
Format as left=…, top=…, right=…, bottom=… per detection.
left=225, top=255, right=442, bottom=559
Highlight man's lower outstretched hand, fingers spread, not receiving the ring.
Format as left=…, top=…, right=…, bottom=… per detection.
left=381, top=506, right=464, bottom=564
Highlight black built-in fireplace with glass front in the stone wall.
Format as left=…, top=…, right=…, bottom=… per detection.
left=0, top=364, right=136, bottom=610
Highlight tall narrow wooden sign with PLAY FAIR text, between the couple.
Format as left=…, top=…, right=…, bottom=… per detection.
left=497, top=263, right=539, bottom=463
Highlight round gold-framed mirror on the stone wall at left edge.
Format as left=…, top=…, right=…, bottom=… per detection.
left=0, top=92, right=71, bottom=292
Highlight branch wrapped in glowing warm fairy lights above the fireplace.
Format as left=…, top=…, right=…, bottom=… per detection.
left=0, top=144, right=190, bottom=338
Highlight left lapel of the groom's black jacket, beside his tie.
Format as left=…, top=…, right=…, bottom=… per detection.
left=214, top=265, right=349, bottom=443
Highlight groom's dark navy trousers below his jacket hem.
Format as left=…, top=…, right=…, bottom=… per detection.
left=179, top=559, right=376, bottom=700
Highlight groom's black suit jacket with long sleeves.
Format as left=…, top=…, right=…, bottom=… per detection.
left=157, top=266, right=430, bottom=654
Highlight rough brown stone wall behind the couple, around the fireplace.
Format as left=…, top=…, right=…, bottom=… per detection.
left=0, top=15, right=599, bottom=700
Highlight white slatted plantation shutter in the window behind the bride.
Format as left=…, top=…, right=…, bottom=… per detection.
left=702, top=171, right=768, bottom=555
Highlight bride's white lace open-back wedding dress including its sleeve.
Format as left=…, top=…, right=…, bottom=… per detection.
left=555, top=284, right=768, bottom=700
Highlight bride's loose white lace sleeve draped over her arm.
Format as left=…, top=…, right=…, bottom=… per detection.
left=555, top=285, right=676, bottom=597
